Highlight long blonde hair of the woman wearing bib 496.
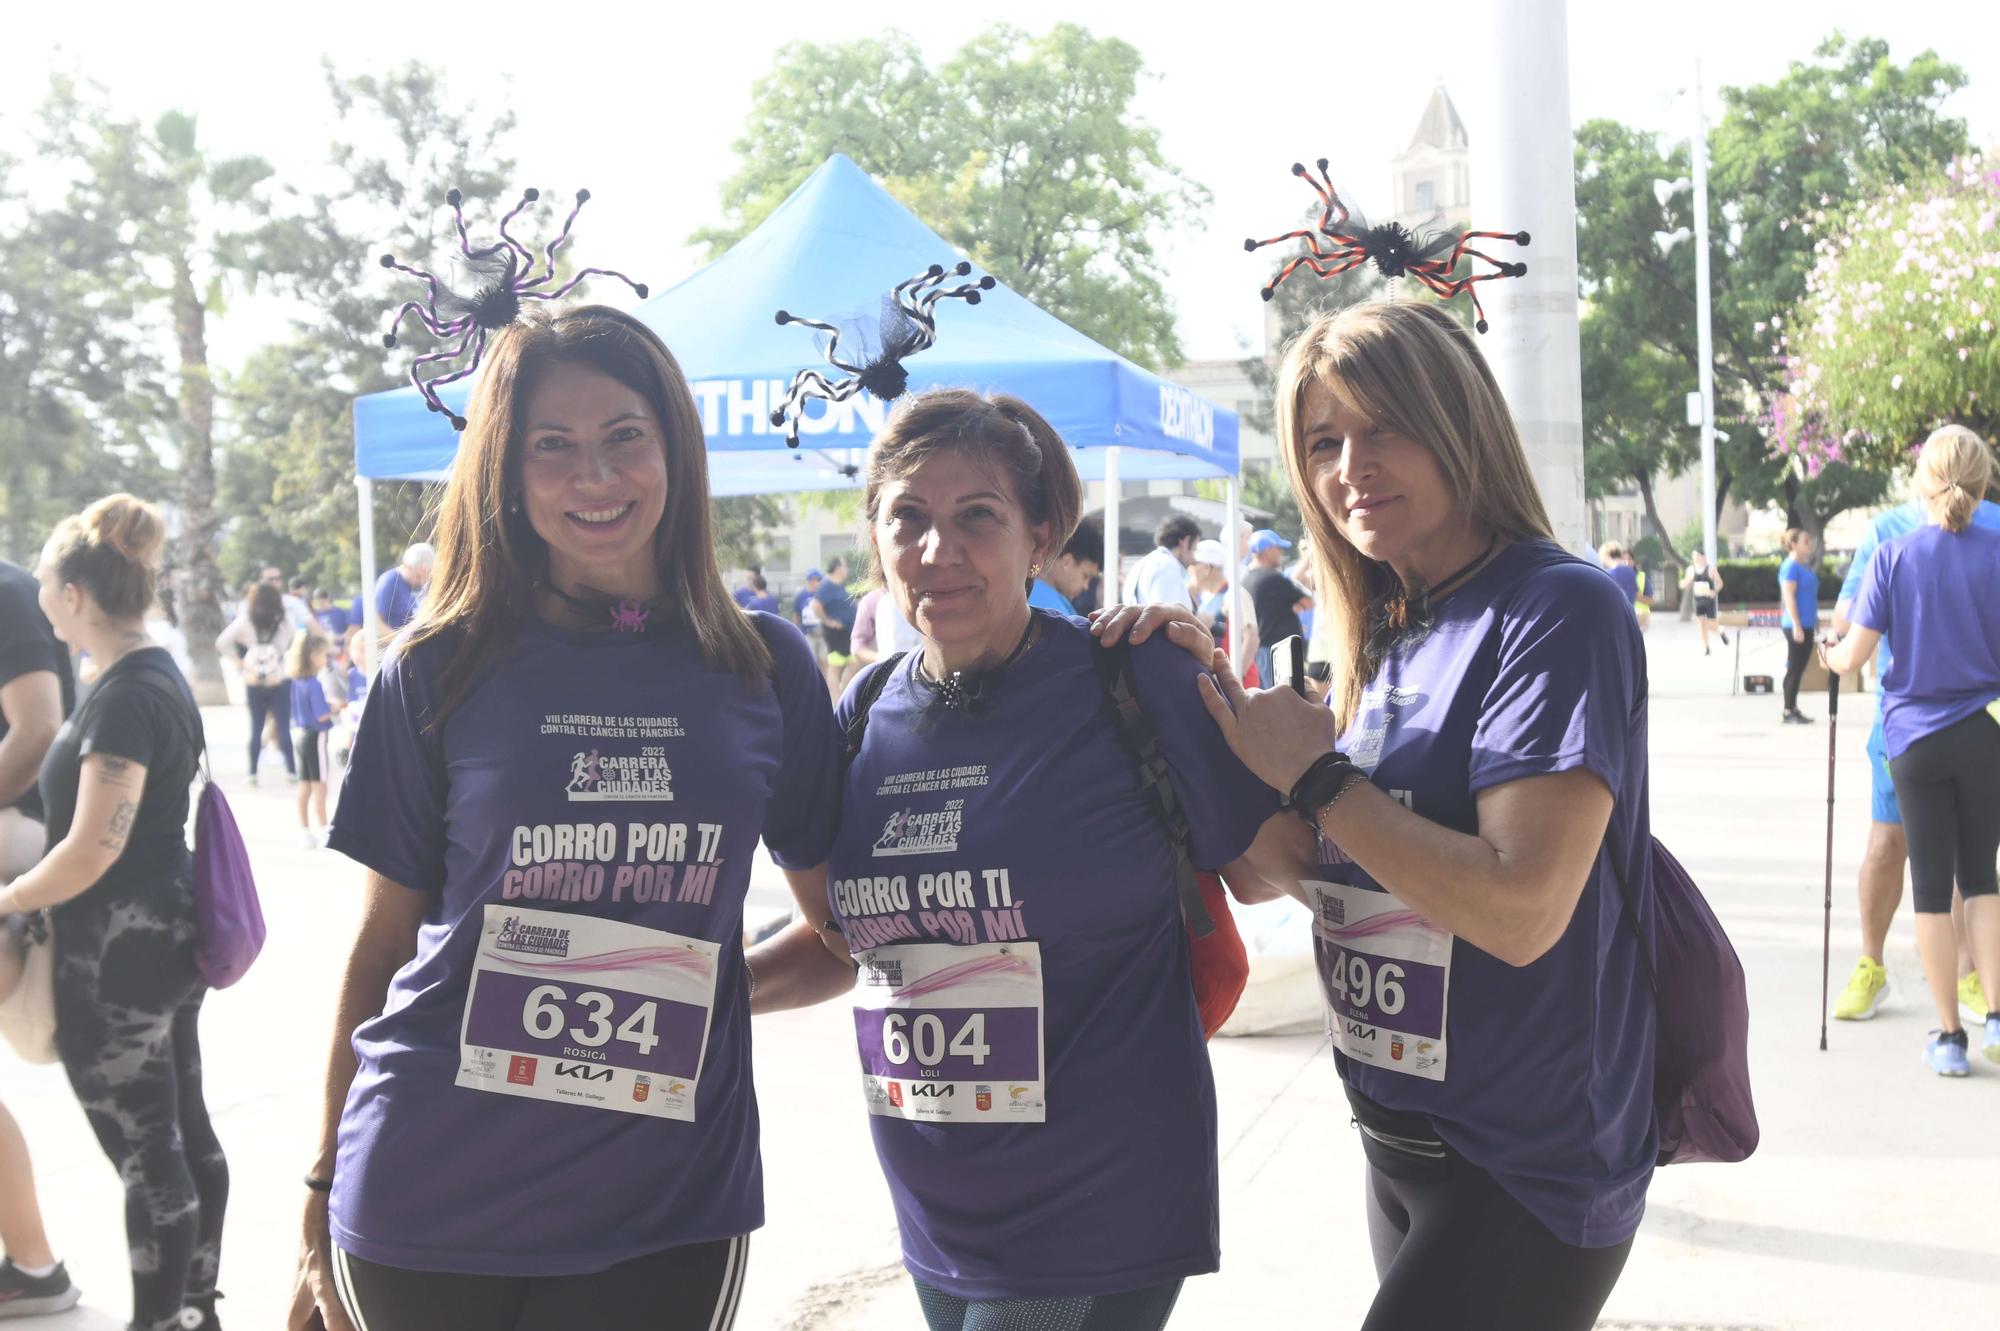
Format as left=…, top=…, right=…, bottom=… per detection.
left=1276, top=304, right=1552, bottom=729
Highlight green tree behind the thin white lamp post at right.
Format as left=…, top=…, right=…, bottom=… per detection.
left=1576, top=34, right=1966, bottom=544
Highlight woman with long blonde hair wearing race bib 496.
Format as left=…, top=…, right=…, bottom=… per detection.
left=1102, top=304, right=1658, bottom=1331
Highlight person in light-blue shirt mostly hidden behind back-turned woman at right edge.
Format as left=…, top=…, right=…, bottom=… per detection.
left=1834, top=489, right=2000, bottom=1023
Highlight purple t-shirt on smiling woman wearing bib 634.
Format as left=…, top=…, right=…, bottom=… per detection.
left=328, top=616, right=840, bottom=1275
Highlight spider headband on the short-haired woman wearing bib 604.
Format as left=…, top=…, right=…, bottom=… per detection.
left=770, top=260, right=994, bottom=448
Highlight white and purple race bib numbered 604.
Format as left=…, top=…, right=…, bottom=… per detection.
left=854, top=941, right=1048, bottom=1123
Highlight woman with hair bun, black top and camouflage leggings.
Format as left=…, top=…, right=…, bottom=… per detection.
left=0, top=494, right=230, bottom=1331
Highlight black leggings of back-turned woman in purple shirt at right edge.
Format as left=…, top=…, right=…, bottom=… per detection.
left=1888, top=709, right=2000, bottom=915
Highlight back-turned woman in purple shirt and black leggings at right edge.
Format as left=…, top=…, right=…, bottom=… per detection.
left=1822, top=426, right=2000, bottom=1077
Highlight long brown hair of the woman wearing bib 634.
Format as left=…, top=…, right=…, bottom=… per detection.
left=404, top=306, right=772, bottom=725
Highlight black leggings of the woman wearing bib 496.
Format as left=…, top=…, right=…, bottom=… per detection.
left=1348, top=1091, right=1632, bottom=1331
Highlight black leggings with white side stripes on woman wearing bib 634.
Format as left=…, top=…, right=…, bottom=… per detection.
left=334, top=1235, right=750, bottom=1331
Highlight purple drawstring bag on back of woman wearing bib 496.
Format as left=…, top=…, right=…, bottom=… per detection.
left=1612, top=837, right=1758, bottom=1165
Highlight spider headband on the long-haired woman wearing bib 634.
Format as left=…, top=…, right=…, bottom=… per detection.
left=382, top=190, right=646, bottom=430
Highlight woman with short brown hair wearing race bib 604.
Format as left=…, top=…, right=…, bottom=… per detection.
left=750, top=390, right=1276, bottom=1331
